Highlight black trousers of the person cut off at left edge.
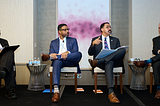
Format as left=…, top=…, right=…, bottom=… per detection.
left=0, top=50, right=16, bottom=91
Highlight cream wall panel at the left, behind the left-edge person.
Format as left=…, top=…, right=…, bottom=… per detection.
left=0, top=0, right=34, bottom=63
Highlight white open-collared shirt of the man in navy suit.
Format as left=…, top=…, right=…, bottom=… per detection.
left=58, top=37, right=67, bottom=54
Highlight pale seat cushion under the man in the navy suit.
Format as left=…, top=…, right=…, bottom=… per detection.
left=49, top=66, right=77, bottom=73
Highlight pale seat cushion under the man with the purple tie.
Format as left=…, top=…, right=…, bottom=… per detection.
left=94, top=67, right=122, bottom=73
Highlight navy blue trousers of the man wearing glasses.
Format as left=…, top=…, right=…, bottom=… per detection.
left=52, top=52, right=82, bottom=85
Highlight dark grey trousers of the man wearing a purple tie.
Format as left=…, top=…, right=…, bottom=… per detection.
left=98, top=49, right=126, bottom=88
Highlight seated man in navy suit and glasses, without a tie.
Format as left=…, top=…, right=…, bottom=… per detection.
left=42, top=24, right=82, bottom=102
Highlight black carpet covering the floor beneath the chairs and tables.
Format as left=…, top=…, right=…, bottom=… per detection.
left=0, top=85, right=160, bottom=106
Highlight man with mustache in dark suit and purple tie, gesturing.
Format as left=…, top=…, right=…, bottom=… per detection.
left=88, top=22, right=126, bottom=103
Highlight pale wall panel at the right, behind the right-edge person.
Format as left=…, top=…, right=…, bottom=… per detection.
left=132, top=0, right=160, bottom=59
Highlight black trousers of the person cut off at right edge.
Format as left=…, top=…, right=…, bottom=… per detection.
left=151, top=54, right=160, bottom=85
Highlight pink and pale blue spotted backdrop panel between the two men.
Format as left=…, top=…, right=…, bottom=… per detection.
left=58, top=0, right=109, bottom=69
